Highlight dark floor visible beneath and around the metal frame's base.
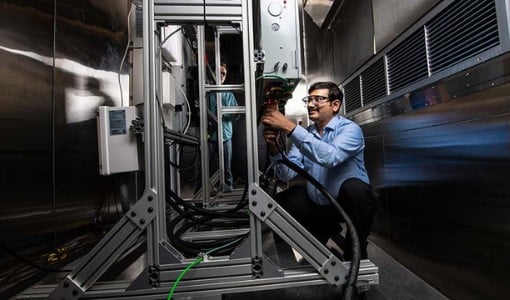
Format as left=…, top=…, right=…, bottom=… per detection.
left=4, top=188, right=448, bottom=300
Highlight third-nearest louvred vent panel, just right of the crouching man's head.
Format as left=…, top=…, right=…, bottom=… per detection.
left=361, top=58, right=386, bottom=105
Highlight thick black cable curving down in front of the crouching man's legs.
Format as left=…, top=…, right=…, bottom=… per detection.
left=278, top=155, right=361, bottom=299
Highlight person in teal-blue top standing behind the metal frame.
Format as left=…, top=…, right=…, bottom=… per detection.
left=208, top=64, right=239, bottom=192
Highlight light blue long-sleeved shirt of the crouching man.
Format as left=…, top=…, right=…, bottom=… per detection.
left=271, top=116, right=370, bottom=205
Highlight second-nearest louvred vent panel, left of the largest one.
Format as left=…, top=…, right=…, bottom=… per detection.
left=386, top=30, right=429, bottom=92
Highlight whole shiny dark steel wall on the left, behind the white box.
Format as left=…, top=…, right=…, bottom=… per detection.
left=0, top=0, right=129, bottom=298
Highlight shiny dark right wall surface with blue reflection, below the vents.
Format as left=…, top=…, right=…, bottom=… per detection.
left=359, top=57, right=510, bottom=299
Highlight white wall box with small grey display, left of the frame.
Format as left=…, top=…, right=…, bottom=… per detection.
left=97, top=106, right=139, bottom=175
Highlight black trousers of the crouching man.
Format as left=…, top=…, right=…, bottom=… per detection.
left=275, top=178, right=376, bottom=260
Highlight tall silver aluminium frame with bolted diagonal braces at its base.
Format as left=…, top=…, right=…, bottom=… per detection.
left=18, top=0, right=378, bottom=299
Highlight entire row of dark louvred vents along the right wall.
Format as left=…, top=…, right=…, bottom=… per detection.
left=343, top=0, right=500, bottom=113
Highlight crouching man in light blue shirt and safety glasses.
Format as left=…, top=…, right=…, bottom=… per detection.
left=262, top=82, right=376, bottom=260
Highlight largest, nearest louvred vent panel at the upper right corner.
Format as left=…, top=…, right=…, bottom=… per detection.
left=426, top=0, right=499, bottom=74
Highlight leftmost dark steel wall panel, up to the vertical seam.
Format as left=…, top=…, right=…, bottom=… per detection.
left=0, top=1, right=53, bottom=270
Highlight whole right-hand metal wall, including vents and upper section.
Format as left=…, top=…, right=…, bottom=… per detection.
left=307, top=0, right=510, bottom=299
